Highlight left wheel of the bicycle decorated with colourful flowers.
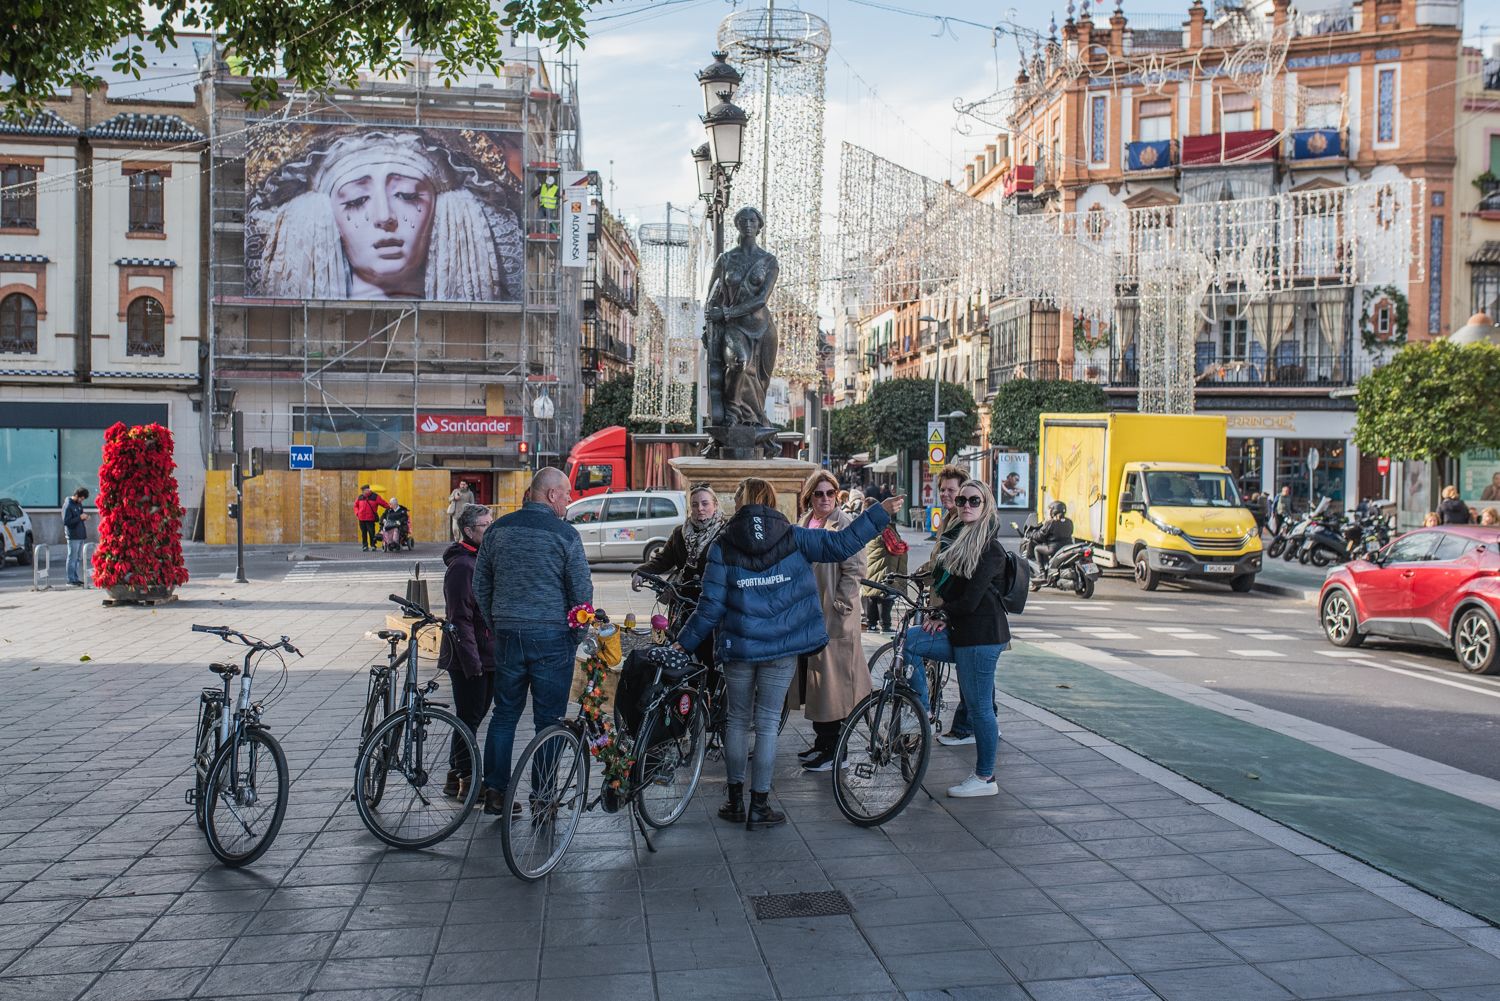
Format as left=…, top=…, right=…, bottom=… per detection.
left=500, top=723, right=588, bottom=882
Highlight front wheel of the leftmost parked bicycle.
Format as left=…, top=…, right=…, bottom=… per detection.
left=203, top=729, right=291, bottom=867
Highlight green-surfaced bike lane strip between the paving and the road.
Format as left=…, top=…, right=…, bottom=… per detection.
left=996, top=642, right=1500, bottom=924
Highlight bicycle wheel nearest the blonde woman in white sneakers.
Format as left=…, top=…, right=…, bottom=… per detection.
left=834, top=686, right=932, bottom=827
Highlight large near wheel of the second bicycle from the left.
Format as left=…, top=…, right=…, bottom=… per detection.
left=354, top=705, right=479, bottom=848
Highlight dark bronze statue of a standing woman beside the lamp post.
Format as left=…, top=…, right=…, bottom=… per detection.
left=704, top=207, right=779, bottom=428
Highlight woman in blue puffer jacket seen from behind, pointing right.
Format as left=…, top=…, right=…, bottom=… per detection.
left=678, top=477, right=902, bottom=830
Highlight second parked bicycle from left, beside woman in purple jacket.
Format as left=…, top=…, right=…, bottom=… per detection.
left=354, top=594, right=480, bottom=848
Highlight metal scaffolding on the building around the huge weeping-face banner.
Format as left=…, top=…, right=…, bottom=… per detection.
left=207, top=47, right=584, bottom=471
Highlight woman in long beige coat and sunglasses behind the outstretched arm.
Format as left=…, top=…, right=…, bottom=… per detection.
left=789, top=470, right=870, bottom=771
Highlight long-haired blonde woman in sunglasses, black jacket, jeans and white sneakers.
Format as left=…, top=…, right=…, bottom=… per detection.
left=906, top=480, right=1011, bottom=798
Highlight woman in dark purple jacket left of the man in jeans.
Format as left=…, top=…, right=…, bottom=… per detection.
left=438, top=504, right=495, bottom=800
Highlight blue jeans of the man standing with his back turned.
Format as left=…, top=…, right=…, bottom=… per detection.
left=485, top=629, right=578, bottom=792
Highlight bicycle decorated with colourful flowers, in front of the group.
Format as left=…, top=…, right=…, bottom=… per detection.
left=501, top=612, right=708, bottom=882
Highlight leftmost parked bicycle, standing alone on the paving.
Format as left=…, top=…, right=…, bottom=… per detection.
left=183, top=624, right=302, bottom=869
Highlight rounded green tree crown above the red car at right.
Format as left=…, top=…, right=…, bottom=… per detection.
left=1355, top=341, right=1500, bottom=459
